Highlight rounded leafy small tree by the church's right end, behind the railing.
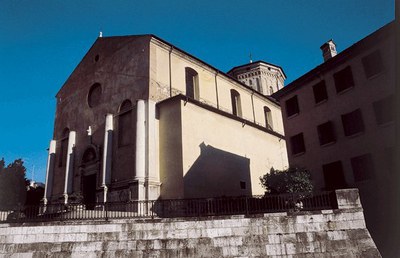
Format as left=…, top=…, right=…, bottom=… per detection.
left=260, top=167, right=314, bottom=194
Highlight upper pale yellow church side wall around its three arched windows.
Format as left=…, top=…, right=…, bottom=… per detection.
left=150, top=39, right=283, bottom=134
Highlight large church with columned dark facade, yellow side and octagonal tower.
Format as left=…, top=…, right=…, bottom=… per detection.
left=44, top=35, right=288, bottom=204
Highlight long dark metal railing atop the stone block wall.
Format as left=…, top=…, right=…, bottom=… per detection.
left=0, top=192, right=337, bottom=222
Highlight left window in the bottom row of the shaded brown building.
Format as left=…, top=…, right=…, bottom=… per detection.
left=322, top=161, right=347, bottom=190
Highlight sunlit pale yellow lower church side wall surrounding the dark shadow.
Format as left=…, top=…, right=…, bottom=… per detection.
left=181, top=100, right=288, bottom=195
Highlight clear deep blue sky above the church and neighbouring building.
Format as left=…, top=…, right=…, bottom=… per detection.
left=0, top=0, right=394, bottom=181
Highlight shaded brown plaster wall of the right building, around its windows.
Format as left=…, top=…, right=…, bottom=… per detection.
left=280, top=24, right=398, bottom=256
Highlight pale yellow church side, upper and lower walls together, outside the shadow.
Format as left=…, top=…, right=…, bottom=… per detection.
left=150, top=40, right=288, bottom=199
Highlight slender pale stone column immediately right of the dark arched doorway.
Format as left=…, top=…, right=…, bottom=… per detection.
left=101, top=114, right=114, bottom=202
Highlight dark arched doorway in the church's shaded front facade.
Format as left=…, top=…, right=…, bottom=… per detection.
left=80, top=145, right=100, bottom=209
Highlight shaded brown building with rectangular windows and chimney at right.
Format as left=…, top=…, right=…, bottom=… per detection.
left=273, top=22, right=397, bottom=254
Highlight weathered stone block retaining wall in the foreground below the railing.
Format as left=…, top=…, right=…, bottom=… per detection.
left=0, top=190, right=381, bottom=258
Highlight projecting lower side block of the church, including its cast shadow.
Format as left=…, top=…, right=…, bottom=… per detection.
left=159, top=99, right=288, bottom=199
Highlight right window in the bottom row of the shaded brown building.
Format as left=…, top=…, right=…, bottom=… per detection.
left=350, top=154, right=374, bottom=182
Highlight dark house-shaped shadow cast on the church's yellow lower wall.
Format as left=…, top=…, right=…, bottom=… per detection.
left=183, top=142, right=252, bottom=198
